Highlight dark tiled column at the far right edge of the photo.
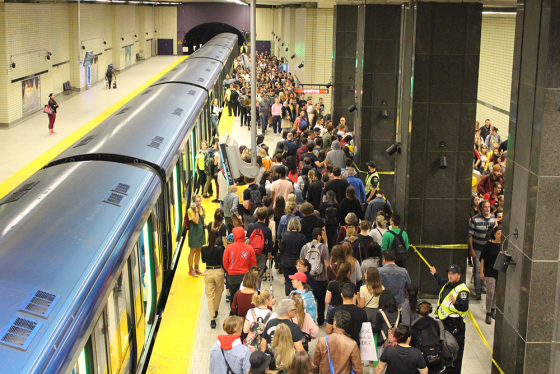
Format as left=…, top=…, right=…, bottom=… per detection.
left=492, top=1, right=560, bottom=374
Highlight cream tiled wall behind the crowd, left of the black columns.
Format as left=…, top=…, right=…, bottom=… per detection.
left=272, top=8, right=334, bottom=113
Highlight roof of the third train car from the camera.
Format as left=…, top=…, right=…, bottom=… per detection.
left=155, top=58, right=223, bottom=90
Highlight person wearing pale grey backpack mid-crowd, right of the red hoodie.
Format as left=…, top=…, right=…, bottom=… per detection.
left=299, top=227, right=331, bottom=326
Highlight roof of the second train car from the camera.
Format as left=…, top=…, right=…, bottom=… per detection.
left=47, top=84, right=208, bottom=175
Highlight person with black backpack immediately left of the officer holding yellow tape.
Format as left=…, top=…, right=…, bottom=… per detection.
left=410, top=301, right=443, bottom=374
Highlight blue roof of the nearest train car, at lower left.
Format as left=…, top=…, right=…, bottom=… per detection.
left=0, top=162, right=161, bottom=373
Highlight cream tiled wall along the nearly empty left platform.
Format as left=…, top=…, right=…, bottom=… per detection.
left=0, top=3, right=172, bottom=124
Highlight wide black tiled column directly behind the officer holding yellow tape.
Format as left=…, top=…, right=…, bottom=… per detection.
left=396, top=2, right=482, bottom=294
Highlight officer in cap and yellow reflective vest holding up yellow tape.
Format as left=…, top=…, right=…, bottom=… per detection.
left=430, top=264, right=470, bottom=374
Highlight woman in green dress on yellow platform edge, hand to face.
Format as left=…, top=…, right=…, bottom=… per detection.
left=187, top=195, right=206, bottom=277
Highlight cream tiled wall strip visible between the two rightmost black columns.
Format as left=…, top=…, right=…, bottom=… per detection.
left=476, top=14, right=515, bottom=138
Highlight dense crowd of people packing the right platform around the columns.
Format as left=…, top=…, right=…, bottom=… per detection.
left=186, top=47, right=498, bottom=374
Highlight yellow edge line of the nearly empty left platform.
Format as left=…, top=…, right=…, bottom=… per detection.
left=0, top=56, right=189, bottom=199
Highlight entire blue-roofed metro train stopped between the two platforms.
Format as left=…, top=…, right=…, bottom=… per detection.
left=0, top=34, right=238, bottom=374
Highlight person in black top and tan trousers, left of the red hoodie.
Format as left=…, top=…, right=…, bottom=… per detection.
left=201, top=223, right=225, bottom=329
